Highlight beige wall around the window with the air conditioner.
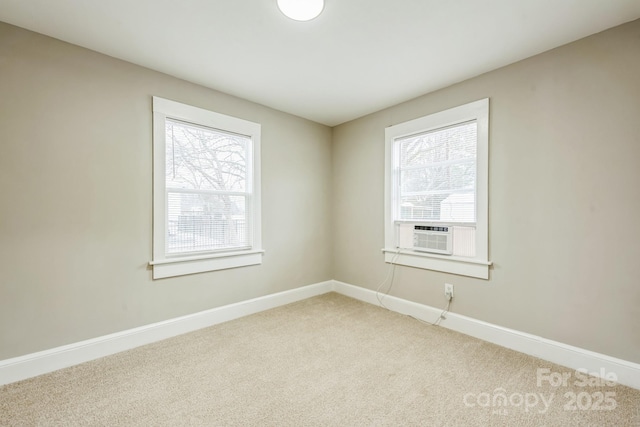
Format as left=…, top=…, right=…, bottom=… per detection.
left=332, top=21, right=640, bottom=362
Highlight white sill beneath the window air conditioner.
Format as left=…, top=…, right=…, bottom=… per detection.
left=382, top=249, right=492, bottom=280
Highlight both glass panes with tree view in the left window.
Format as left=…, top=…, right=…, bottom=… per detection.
left=166, top=119, right=251, bottom=254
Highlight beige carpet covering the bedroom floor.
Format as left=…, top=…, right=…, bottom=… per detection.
left=0, top=293, right=640, bottom=426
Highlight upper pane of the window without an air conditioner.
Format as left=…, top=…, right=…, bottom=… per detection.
left=166, top=119, right=251, bottom=192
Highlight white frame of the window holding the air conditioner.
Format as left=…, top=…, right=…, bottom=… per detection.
left=383, top=98, right=491, bottom=279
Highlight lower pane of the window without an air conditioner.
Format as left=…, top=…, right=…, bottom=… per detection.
left=166, top=191, right=249, bottom=254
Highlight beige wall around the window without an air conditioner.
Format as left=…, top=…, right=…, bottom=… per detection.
left=0, top=23, right=332, bottom=360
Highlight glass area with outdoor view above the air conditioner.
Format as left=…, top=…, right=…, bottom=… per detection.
left=396, top=121, right=477, bottom=223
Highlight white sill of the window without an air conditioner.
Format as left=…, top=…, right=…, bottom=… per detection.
left=149, top=250, right=264, bottom=279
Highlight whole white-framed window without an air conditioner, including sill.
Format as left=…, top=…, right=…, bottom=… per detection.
left=151, top=97, right=263, bottom=279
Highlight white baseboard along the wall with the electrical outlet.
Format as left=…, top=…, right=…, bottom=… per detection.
left=333, top=280, right=640, bottom=389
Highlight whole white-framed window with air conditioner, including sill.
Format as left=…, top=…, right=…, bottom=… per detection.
left=384, top=99, right=491, bottom=279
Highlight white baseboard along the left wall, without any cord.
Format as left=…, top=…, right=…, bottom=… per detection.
left=0, top=281, right=333, bottom=385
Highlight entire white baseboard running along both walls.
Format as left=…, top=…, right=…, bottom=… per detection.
left=0, top=280, right=640, bottom=389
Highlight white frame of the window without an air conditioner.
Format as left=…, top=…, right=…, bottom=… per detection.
left=149, top=96, right=264, bottom=279
